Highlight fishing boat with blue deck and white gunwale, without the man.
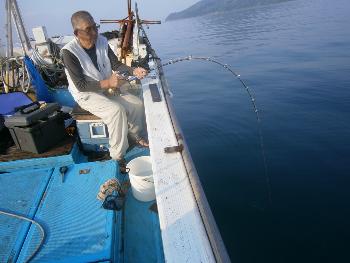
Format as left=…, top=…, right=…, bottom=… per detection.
left=0, top=0, right=230, bottom=262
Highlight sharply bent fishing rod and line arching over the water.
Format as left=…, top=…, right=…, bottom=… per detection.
left=152, top=55, right=272, bottom=205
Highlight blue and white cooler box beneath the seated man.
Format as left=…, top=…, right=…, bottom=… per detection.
left=72, top=106, right=109, bottom=152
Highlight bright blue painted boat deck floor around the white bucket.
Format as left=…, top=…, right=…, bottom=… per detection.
left=0, top=145, right=164, bottom=262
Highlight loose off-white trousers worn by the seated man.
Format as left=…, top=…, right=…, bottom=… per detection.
left=77, top=92, right=145, bottom=160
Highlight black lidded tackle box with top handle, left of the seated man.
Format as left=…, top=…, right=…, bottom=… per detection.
left=5, top=102, right=66, bottom=153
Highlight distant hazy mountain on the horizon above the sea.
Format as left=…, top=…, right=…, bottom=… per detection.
left=165, top=0, right=290, bottom=21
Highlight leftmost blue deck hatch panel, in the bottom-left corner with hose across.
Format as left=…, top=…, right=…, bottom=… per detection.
left=0, top=169, right=52, bottom=262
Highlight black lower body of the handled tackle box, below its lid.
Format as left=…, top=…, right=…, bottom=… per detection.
left=9, top=112, right=66, bottom=153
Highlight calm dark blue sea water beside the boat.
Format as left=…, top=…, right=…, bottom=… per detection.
left=149, top=0, right=350, bottom=262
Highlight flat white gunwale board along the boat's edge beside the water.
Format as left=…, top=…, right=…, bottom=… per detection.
left=142, top=68, right=215, bottom=262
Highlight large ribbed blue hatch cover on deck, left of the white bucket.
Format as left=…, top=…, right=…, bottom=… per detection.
left=19, top=161, right=118, bottom=262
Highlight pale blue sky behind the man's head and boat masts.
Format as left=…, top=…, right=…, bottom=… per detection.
left=0, top=0, right=199, bottom=44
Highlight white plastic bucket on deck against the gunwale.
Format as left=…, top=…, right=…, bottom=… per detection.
left=127, top=156, right=156, bottom=202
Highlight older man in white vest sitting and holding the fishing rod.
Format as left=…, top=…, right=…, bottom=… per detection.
left=62, top=11, right=148, bottom=172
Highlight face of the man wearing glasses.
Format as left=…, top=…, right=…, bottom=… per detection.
left=74, top=20, right=99, bottom=48
